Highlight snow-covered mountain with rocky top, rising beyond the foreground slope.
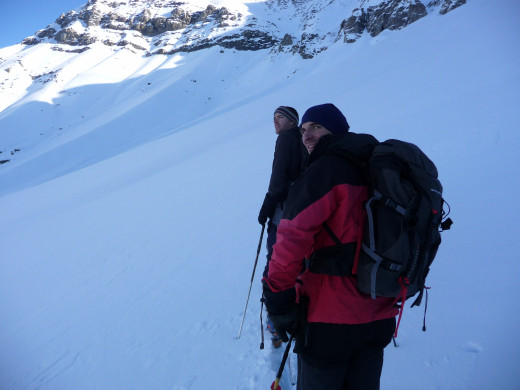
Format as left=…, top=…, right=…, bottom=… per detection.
left=0, top=0, right=465, bottom=194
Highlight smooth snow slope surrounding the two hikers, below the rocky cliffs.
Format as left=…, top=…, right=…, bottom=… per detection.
left=0, top=0, right=520, bottom=390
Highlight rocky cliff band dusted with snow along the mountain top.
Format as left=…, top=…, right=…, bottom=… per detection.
left=23, top=0, right=465, bottom=58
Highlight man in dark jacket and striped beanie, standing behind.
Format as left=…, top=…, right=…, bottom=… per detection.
left=258, top=106, right=307, bottom=348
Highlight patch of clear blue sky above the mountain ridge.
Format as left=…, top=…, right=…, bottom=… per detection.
left=0, top=0, right=84, bottom=47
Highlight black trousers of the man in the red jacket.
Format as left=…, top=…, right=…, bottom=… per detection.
left=296, top=318, right=395, bottom=390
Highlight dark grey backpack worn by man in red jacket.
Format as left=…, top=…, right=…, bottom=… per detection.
left=353, top=139, right=452, bottom=306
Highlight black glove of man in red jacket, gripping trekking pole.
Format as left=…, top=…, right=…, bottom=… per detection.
left=264, top=284, right=300, bottom=342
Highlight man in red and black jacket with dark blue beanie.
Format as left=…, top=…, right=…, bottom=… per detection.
left=263, top=103, right=398, bottom=390
